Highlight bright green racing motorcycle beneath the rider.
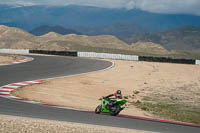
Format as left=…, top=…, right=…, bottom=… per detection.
left=95, top=97, right=127, bottom=116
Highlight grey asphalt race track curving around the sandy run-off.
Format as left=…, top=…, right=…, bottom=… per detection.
left=0, top=56, right=200, bottom=133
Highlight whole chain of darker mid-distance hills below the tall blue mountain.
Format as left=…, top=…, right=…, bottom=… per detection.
left=30, top=24, right=200, bottom=50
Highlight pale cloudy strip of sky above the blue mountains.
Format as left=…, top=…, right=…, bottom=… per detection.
left=0, top=0, right=200, bottom=16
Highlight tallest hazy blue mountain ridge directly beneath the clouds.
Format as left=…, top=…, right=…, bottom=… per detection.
left=0, top=5, right=200, bottom=32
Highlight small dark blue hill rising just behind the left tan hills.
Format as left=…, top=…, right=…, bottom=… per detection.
left=29, top=25, right=81, bottom=36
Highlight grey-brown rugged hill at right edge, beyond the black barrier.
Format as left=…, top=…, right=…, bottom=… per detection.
left=124, top=26, right=200, bottom=50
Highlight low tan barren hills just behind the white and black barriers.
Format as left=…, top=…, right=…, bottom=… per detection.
left=0, top=26, right=172, bottom=55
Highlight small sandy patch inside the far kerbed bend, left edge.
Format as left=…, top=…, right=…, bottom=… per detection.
left=0, top=55, right=24, bottom=65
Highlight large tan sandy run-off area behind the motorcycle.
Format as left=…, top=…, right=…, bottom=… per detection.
left=14, top=60, right=200, bottom=117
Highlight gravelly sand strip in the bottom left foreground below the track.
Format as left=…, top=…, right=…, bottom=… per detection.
left=0, top=115, right=150, bottom=133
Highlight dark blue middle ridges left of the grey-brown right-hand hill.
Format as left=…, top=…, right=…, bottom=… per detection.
left=29, top=24, right=148, bottom=39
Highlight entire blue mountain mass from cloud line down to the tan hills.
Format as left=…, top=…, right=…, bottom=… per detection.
left=0, top=5, right=200, bottom=50
